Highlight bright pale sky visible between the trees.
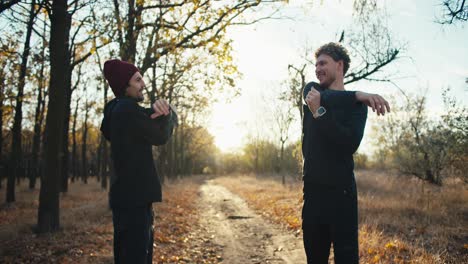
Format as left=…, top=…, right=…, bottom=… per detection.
left=208, top=0, right=468, bottom=153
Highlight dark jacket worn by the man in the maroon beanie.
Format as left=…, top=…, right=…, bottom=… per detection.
left=101, top=97, right=177, bottom=208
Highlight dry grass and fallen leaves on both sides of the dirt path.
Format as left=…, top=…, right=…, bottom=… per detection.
left=0, top=171, right=468, bottom=263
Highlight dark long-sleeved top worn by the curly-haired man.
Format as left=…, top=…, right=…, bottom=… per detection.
left=302, top=82, right=367, bottom=188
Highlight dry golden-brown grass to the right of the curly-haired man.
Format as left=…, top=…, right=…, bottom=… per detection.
left=357, top=171, right=468, bottom=263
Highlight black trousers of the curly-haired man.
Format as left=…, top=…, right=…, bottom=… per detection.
left=302, top=181, right=359, bottom=264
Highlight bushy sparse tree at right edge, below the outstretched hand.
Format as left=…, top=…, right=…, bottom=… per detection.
left=374, top=87, right=468, bottom=185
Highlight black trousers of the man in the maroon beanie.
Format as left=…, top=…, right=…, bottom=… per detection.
left=112, top=204, right=153, bottom=264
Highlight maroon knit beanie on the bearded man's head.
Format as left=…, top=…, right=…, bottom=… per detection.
left=104, top=59, right=140, bottom=96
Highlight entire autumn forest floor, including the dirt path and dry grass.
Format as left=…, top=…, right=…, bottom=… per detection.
left=0, top=171, right=468, bottom=264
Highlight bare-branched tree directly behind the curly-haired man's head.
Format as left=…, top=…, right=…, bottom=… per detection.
left=281, top=0, right=405, bottom=119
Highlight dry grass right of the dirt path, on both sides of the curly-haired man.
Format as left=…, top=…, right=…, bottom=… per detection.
left=217, top=171, right=468, bottom=263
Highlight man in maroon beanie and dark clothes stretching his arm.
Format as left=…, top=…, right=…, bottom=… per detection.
left=101, top=60, right=177, bottom=264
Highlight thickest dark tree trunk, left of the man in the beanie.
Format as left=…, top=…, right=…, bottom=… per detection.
left=37, top=0, right=71, bottom=233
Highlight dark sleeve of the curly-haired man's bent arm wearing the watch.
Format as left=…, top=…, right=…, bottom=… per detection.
left=316, top=104, right=367, bottom=154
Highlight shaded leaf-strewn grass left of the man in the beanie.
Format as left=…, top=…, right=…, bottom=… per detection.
left=0, top=180, right=112, bottom=263
